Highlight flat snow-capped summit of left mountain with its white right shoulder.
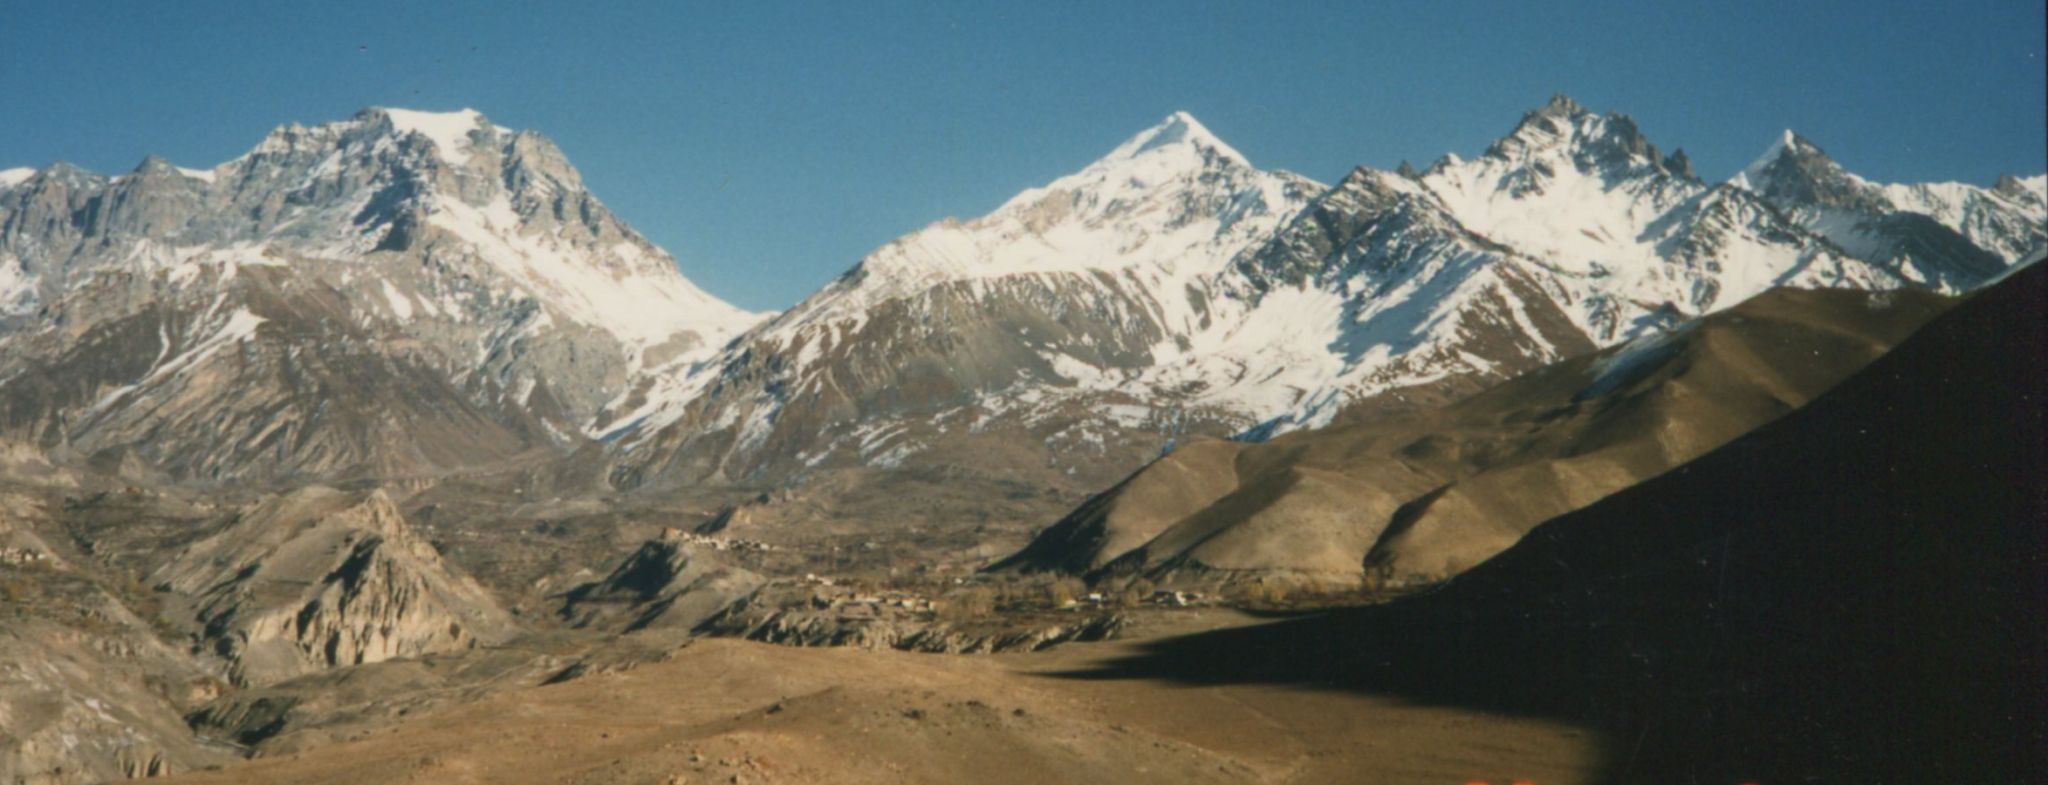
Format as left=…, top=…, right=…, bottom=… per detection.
left=201, top=107, right=762, bottom=353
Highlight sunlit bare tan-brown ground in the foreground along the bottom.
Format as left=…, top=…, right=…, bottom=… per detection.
left=155, top=609, right=1606, bottom=785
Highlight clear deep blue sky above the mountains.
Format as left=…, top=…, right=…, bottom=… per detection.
left=0, top=0, right=2048, bottom=307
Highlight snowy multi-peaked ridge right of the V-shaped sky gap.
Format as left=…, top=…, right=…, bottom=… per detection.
left=614, top=96, right=2042, bottom=498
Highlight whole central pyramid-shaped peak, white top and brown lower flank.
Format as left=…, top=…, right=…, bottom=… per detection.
left=610, top=113, right=1323, bottom=485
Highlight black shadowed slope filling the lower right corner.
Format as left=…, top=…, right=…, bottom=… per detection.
left=1067, top=264, right=2048, bottom=785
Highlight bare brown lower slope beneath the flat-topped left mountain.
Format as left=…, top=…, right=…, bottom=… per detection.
left=0, top=266, right=555, bottom=488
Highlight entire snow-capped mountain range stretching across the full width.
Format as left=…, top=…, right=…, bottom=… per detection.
left=0, top=96, right=2048, bottom=498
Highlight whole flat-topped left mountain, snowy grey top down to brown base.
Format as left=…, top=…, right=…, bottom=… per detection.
left=0, top=109, right=758, bottom=482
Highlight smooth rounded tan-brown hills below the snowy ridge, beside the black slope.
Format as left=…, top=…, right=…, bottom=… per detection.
left=1004, top=289, right=1950, bottom=586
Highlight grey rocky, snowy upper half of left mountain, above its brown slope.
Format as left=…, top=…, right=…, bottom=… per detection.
left=0, top=109, right=764, bottom=442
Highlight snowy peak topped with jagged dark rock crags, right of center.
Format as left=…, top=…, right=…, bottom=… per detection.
left=1419, top=96, right=1894, bottom=344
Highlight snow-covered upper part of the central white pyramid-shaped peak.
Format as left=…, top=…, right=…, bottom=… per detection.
left=679, top=113, right=1323, bottom=398
